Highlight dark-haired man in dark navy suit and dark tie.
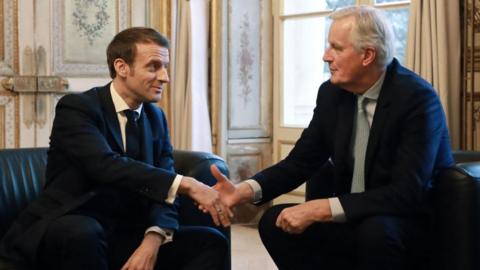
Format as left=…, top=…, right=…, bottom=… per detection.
left=2, top=27, right=229, bottom=270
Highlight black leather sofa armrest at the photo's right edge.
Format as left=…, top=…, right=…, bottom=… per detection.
left=432, top=162, right=480, bottom=270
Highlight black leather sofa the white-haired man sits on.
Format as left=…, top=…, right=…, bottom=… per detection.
left=305, top=151, right=480, bottom=270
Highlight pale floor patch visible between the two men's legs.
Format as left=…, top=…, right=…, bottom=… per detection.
left=231, top=224, right=278, bottom=270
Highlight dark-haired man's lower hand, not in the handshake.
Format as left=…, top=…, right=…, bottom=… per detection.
left=121, top=232, right=164, bottom=270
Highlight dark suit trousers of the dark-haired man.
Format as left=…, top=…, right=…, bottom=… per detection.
left=39, top=214, right=228, bottom=270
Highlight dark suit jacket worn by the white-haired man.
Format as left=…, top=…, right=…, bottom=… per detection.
left=253, top=59, right=453, bottom=220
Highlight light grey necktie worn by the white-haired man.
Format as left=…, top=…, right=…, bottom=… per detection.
left=351, top=96, right=370, bottom=193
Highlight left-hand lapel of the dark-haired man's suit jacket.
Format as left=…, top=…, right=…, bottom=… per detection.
left=99, top=84, right=125, bottom=152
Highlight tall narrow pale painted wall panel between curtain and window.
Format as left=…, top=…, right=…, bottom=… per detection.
left=226, top=0, right=271, bottom=138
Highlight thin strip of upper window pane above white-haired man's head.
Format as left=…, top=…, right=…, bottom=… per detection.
left=283, top=0, right=355, bottom=15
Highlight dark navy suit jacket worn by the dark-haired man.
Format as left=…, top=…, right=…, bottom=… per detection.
left=0, top=84, right=178, bottom=263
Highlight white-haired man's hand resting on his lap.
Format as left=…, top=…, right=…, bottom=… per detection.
left=276, top=199, right=332, bottom=234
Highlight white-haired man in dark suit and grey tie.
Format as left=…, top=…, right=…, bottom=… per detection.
left=212, top=6, right=453, bottom=270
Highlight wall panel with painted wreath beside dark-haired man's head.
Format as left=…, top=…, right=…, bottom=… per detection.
left=52, top=0, right=130, bottom=76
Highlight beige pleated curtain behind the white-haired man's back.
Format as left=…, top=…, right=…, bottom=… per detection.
left=406, top=0, right=461, bottom=149
